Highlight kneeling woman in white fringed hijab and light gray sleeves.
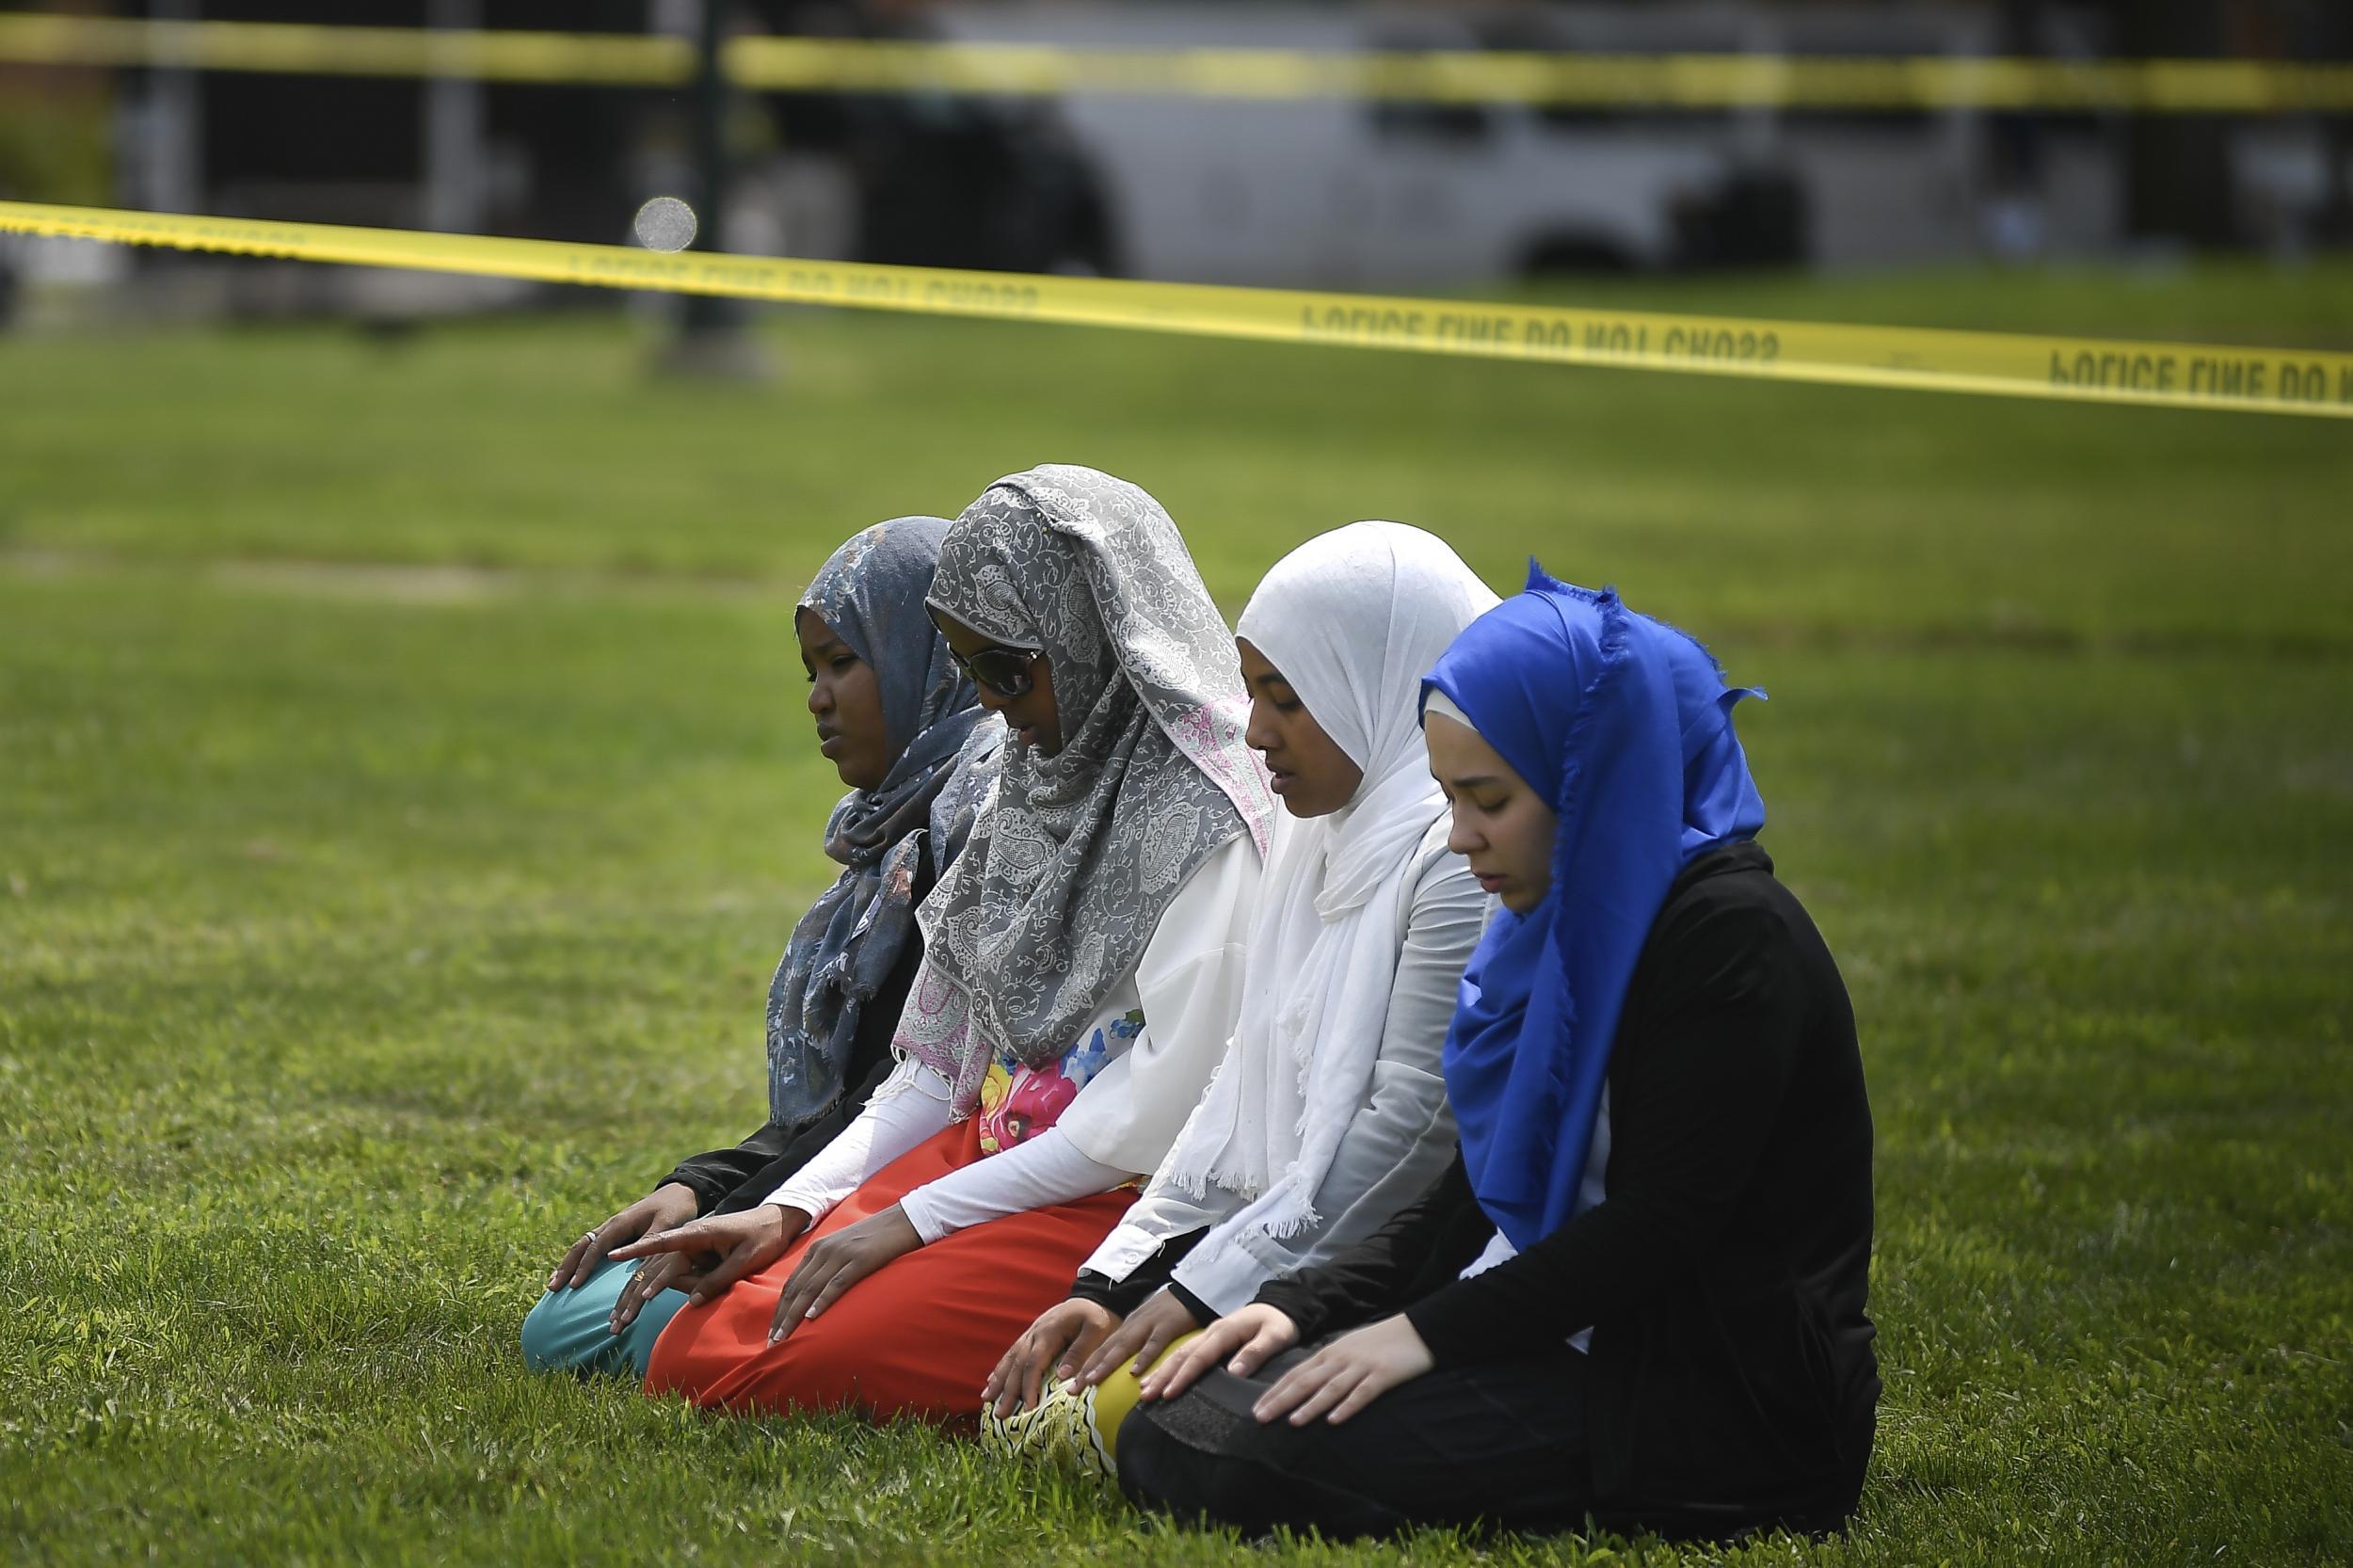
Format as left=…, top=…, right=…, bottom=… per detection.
left=984, top=522, right=1497, bottom=1469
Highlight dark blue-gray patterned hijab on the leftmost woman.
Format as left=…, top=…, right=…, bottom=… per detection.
left=767, top=518, right=1005, bottom=1126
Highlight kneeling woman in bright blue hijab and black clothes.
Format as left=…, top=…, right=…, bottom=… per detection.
left=1120, top=568, right=1881, bottom=1537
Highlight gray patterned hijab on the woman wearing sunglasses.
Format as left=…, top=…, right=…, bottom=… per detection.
left=897, top=464, right=1273, bottom=1116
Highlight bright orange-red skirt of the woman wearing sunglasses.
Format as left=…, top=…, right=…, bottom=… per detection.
left=645, top=1116, right=1137, bottom=1429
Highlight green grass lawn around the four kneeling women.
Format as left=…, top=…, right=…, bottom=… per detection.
left=0, top=268, right=2353, bottom=1568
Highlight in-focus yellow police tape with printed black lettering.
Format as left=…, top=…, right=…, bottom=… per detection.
left=0, top=202, right=2353, bottom=419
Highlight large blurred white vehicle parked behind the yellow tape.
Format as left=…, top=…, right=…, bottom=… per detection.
left=920, top=0, right=2122, bottom=290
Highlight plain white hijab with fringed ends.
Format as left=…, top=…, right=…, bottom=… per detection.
left=1153, top=522, right=1497, bottom=1257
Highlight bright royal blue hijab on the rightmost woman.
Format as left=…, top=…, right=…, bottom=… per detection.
left=1421, top=563, right=1765, bottom=1250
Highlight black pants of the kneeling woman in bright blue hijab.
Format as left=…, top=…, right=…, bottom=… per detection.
left=1120, top=1347, right=1593, bottom=1537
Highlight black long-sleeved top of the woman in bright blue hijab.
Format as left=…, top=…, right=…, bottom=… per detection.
left=1259, top=845, right=1881, bottom=1532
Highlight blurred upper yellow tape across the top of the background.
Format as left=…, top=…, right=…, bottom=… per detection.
left=0, top=14, right=2353, bottom=116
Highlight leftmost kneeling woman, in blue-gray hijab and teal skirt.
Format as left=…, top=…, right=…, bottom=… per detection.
left=522, top=518, right=1005, bottom=1377
